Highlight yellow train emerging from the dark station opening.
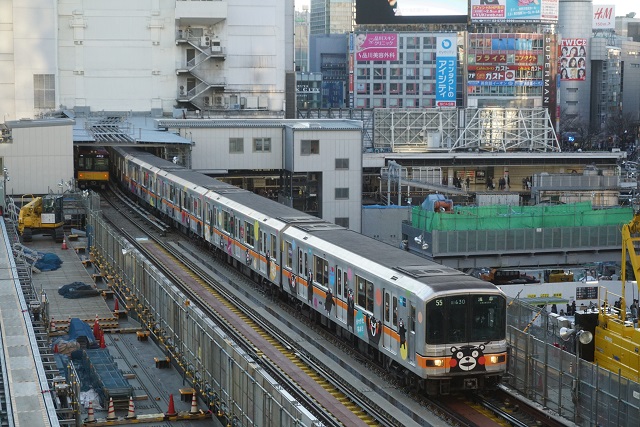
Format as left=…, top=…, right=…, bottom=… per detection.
left=73, top=145, right=110, bottom=189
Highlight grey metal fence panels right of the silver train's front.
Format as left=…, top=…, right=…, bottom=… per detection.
left=507, top=300, right=640, bottom=427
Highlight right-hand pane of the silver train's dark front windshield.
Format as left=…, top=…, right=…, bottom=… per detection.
left=471, top=295, right=506, bottom=341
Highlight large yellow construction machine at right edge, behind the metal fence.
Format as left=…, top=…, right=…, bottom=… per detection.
left=594, top=210, right=640, bottom=382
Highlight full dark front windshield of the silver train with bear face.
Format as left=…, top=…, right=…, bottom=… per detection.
left=425, top=295, right=506, bottom=344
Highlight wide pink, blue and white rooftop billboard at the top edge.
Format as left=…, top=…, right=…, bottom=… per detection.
left=470, top=0, right=559, bottom=22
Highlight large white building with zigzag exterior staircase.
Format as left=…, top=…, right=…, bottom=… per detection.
left=0, top=0, right=294, bottom=120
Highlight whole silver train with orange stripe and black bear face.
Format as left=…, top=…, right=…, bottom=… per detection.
left=110, top=147, right=508, bottom=396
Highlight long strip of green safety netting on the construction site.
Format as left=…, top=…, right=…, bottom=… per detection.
left=411, top=202, right=633, bottom=232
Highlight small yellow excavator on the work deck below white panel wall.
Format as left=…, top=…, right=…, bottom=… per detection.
left=18, top=194, right=64, bottom=243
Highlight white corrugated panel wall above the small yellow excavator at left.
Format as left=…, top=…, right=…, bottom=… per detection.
left=0, top=124, right=73, bottom=198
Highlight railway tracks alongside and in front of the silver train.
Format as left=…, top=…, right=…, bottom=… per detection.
left=96, top=187, right=562, bottom=426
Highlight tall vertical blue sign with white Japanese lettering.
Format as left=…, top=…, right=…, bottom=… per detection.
left=436, top=36, right=458, bottom=107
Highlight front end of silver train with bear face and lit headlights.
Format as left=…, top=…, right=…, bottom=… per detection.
left=417, top=272, right=507, bottom=395
